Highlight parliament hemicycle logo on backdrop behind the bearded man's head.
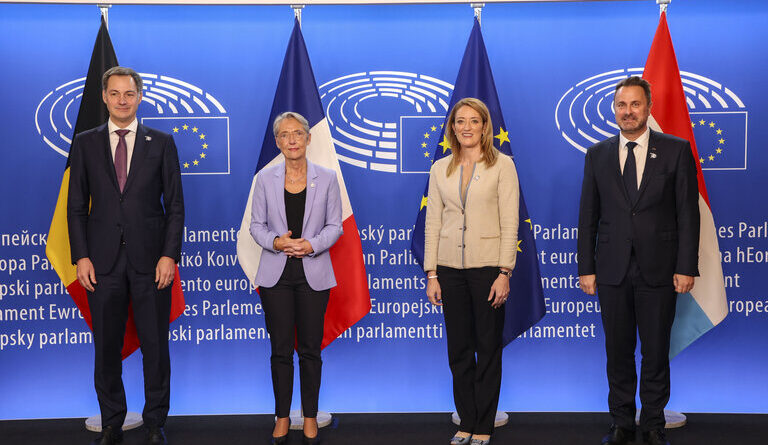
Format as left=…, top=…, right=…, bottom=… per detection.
left=555, top=68, right=748, bottom=170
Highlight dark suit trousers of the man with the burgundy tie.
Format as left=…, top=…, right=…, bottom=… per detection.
left=88, top=247, right=171, bottom=429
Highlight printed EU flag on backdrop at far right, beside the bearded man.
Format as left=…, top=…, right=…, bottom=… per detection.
left=691, top=111, right=747, bottom=170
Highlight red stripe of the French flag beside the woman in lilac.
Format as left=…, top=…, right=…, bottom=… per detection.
left=322, top=215, right=371, bottom=348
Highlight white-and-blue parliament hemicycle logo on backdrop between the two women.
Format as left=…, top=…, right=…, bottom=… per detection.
left=319, top=71, right=453, bottom=173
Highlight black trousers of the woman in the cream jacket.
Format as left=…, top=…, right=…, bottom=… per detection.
left=437, top=266, right=504, bottom=434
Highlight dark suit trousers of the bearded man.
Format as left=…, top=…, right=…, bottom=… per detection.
left=597, top=254, right=677, bottom=431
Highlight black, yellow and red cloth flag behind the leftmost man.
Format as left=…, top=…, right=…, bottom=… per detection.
left=45, top=17, right=184, bottom=359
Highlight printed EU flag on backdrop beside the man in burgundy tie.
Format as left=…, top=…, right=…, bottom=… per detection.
left=141, top=116, right=229, bottom=175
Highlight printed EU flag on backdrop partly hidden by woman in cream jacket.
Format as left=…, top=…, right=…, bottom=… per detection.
left=400, top=116, right=445, bottom=173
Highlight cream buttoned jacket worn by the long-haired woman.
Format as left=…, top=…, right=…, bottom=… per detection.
left=424, top=153, right=520, bottom=271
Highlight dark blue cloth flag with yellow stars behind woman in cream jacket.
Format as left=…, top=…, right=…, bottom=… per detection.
left=411, top=19, right=546, bottom=345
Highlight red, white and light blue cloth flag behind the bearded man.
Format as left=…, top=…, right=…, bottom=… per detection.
left=643, top=12, right=728, bottom=358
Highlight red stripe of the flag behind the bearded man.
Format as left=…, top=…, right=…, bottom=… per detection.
left=643, top=12, right=712, bottom=208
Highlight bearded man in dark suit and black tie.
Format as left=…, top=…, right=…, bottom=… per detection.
left=578, top=77, right=699, bottom=445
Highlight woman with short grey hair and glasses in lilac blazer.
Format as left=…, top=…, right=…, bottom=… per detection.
left=251, top=112, right=342, bottom=444
